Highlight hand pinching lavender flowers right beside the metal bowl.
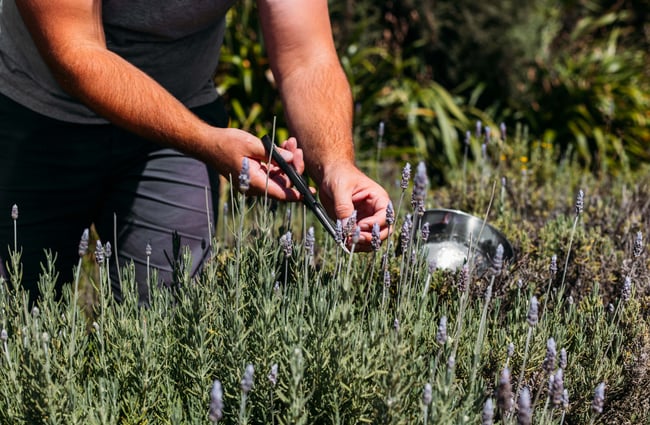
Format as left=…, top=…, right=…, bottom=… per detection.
left=320, top=164, right=390, bottom=251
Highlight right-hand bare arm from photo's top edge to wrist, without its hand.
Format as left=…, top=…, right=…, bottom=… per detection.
left=258, top=0, right=354, bottom=183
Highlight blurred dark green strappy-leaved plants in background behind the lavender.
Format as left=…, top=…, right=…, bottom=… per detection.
left=217, top=0, right=650, bottom=183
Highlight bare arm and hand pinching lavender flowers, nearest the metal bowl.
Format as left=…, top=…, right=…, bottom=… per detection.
left=258, top=0, right=389, bottom=244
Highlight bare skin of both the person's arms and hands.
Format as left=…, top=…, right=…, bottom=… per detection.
left=16, top=0, right=389, bottom=250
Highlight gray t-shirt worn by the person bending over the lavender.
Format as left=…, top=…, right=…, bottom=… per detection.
left=0, top=0, right=235, bottom=123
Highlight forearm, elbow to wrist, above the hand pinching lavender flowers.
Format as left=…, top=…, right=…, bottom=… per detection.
left=279, top=59, right=354, bottom=182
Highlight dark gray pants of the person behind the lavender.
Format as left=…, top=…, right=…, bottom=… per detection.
left=0, top=95, right=228, bottom=301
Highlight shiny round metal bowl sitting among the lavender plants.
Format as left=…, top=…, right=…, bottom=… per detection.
left=414, top=209, right=515, bottom=273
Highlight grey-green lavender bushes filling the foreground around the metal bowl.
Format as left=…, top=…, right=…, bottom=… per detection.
left=0, top=128, right=650, bottom=424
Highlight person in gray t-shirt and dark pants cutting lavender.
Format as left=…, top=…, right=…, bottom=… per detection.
left=0, top=0, right=389, bottom=304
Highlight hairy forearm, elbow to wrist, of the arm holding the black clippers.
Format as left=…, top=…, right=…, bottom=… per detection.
left=50, top=46, right=214, bottom=164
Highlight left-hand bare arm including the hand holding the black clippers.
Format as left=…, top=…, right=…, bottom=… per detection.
left=16, top=0, right=302, bottom=199
